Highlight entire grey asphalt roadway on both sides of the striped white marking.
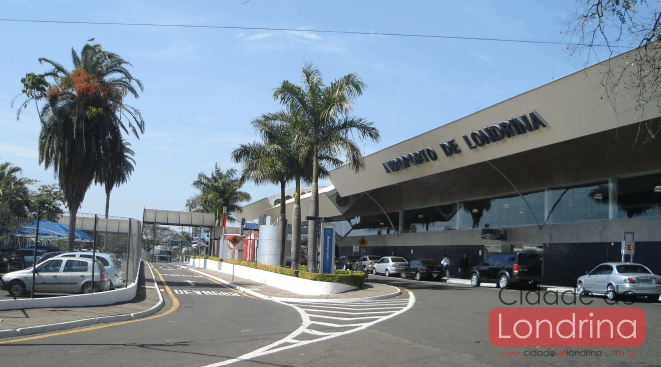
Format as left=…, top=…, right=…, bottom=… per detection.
left=0, top=265, right=661, bottom=367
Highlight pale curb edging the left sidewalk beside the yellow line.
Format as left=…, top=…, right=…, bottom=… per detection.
left=0, top=262, right=165, bottom=339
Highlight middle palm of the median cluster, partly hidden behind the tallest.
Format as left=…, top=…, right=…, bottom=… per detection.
left=249, top=109, right=342, bottom=269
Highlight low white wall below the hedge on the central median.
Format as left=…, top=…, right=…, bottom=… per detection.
left=190, top=259, right=358, bottom=296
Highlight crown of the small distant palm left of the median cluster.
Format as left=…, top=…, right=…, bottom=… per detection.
left=193, top=163, right=251, bottom=221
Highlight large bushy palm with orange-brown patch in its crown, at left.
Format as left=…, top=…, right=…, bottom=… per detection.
left=18, top=43, right=145, bottom=251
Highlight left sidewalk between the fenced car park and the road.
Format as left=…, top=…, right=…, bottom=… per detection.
left=0, top=263, right=164, bottom=338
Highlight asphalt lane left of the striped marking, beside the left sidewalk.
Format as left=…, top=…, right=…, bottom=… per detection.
left=0, top=263, right=301, bottom=367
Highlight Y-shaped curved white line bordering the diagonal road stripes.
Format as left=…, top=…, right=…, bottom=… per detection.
left=204, top=291, right=415, bottom=367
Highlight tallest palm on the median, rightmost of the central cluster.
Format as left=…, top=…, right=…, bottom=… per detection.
left=273, top=63, right=380, bottom=272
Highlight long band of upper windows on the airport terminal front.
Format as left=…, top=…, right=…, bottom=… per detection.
left=340, top=173, right=661, bottom=236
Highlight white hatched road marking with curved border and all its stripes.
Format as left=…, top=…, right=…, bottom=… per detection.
left=205, top=291, right=415, bottom=367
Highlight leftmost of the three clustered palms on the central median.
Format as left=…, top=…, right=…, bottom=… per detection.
left=232, top=123, right=294, bottom=266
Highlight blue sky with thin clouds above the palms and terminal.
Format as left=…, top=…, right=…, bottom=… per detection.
left=0, top=0, right=620, bottom=219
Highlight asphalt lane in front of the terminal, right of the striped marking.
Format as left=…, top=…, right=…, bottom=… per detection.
left=250, top=276, right=661, bottom=367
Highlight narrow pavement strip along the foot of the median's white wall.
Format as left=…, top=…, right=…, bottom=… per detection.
left=180, top=265, right=402, bottom=302
